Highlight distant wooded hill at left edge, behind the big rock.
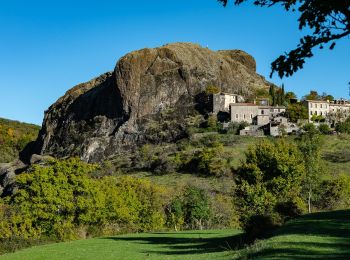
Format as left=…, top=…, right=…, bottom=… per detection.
left=0, top=118, right=40, bottom=163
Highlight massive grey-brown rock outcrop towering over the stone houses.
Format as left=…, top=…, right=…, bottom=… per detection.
left=31, top=43, right=269, bottom=162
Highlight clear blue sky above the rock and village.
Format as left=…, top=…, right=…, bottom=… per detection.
left=0, top=0, right=350, bottom=124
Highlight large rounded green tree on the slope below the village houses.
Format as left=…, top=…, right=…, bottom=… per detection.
left=235, top=139, right=305, bottom=222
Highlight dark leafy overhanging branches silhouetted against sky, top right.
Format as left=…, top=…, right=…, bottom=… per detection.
left=218, top=0, right=350, bottom=78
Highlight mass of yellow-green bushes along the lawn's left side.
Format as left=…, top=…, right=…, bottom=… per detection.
left=0, top=158, right=164, bottom=239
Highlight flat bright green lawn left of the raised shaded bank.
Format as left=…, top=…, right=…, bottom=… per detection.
left=0, top=230, right=241, bottom=260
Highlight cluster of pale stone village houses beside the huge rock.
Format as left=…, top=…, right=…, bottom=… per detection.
left=212, top=92, right=350, bottom=136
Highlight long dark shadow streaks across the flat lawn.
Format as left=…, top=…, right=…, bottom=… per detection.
left=105, top=232, right=244, bottom=255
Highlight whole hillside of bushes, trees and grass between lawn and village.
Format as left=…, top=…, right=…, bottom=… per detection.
left=0, top=110, right=350, bottom=252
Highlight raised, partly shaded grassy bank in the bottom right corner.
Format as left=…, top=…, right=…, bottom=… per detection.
left=235, top=210, right=350, bottom=259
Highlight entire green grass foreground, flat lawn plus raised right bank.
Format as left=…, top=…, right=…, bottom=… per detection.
left=0, top=210, right=350, bottom=259
